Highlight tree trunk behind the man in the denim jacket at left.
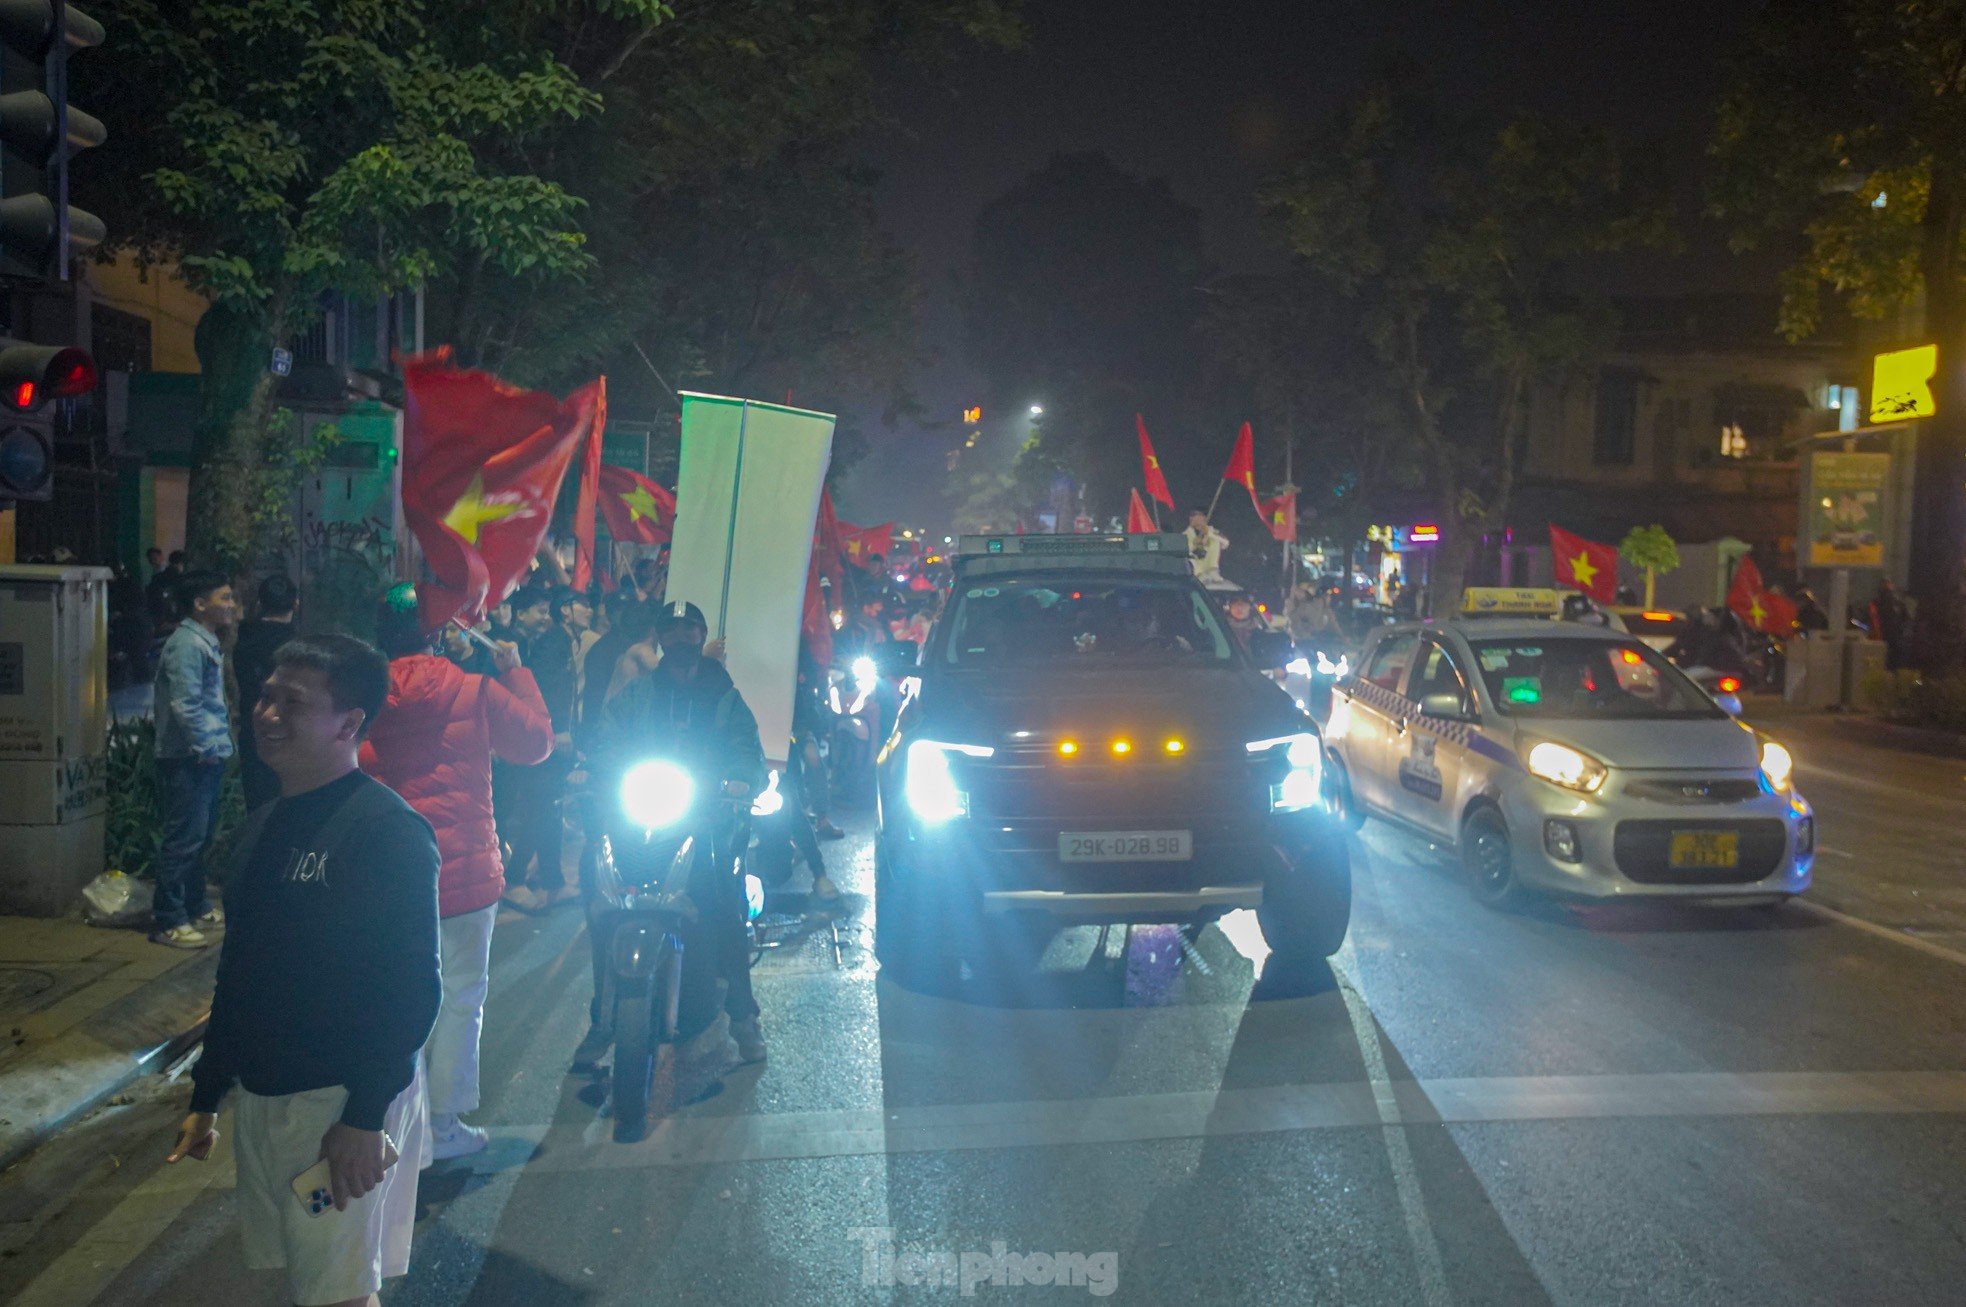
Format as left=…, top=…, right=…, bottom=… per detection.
left=185, top=305, right=273, bottom=574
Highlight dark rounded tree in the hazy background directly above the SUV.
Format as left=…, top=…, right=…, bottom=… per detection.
left=967, top=153, right=1211, bottom=517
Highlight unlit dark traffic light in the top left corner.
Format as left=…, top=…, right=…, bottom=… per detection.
left=0, top=0, right=106, bottom=281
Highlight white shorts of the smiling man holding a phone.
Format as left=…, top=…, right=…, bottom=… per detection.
left=232, top=1055, right=431, bottom=1307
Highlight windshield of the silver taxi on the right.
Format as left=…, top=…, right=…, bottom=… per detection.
left=1469, top=639, right=1726, bottom=719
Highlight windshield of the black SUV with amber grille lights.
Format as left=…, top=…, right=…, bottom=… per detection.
left=942, top=576, right=1235, bottom=668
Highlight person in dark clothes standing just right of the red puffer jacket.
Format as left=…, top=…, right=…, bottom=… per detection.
left=505, top=590, right=580, bottom=912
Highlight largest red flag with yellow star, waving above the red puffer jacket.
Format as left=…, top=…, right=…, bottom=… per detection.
left=403, top=348, right=607, bottom=631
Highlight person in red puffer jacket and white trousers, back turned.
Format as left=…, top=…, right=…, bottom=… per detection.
left=362, top=586, right=552, bottom=1162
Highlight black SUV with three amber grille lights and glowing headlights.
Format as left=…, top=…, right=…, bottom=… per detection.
left=875, top=535, right=1351, bottom=979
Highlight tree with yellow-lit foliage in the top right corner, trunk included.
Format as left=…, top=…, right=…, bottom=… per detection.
left=1710, top=0, right=1966, bottom=670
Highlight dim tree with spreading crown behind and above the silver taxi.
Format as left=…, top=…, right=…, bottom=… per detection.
left=1262, top=86, right=1667, bottom=611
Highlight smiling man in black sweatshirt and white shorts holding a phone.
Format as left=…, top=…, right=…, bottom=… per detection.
left=167, top=635, right=442, bottom=1307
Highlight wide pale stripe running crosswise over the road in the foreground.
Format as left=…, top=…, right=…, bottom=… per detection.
left=422, top=1071, right=1966, bottom=1175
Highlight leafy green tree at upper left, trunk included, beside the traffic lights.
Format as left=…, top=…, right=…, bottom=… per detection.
left=83, top=0, right=605, bottom=568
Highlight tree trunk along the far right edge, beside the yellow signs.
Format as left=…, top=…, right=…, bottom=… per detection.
left=1911, top=167, right=1966, bottom=672
